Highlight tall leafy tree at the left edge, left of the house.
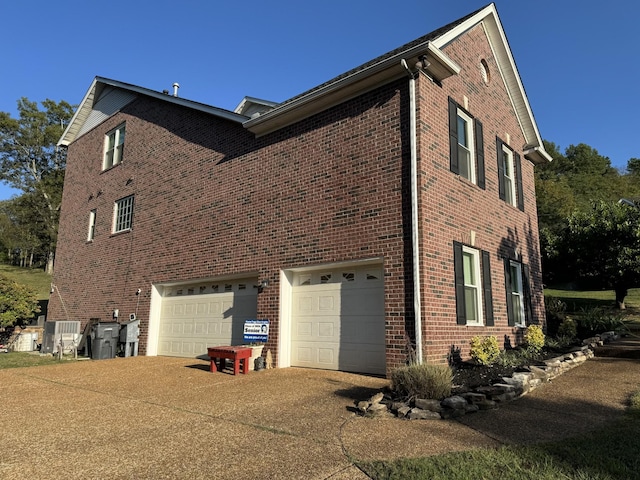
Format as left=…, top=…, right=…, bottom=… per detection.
left=0, top=98, right=74, bottom=273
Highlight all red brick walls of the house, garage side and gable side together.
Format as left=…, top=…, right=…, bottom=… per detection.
left=49, top=22, right=544, bottom=368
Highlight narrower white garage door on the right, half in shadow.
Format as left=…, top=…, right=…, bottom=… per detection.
left=291, top=266, right=386, bottom=374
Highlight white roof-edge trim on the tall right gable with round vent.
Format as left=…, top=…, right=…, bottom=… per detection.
left=433, top=3, right=551, bottom=159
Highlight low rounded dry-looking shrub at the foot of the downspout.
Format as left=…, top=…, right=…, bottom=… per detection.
left=391, top=363, right=453, bottom=400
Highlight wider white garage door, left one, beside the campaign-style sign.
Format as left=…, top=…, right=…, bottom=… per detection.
left=158, top=279, right=257, bottom=357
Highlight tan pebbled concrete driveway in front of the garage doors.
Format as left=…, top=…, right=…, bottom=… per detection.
left=0, top=357, right=640, bottom=480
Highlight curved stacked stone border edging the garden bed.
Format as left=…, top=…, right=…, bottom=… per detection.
left=356, top=337, right=603, bottom=420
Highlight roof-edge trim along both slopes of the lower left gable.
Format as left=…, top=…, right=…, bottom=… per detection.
left=58, top=77, right=248, bottom=146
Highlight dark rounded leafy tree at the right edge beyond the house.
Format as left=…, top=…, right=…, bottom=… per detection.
left=557, top=201, right=640, bottom=308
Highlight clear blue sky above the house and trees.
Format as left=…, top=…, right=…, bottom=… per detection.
left=0, top=0, right=640, bottom=200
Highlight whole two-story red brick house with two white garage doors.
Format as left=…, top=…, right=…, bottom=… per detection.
left=48, top=4, right=550, bottom=374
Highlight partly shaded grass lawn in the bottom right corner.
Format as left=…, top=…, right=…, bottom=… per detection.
left=359, top=390, right=640, bottom=480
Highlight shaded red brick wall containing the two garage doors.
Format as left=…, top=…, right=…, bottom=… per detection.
left=49, top=82, right=413, bottom=364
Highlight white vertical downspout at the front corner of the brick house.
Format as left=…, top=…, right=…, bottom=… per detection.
left=400, top=58, right=422, bottom=364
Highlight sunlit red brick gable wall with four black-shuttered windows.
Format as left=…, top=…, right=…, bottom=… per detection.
left=419, top=22, right=544, bottom=362
